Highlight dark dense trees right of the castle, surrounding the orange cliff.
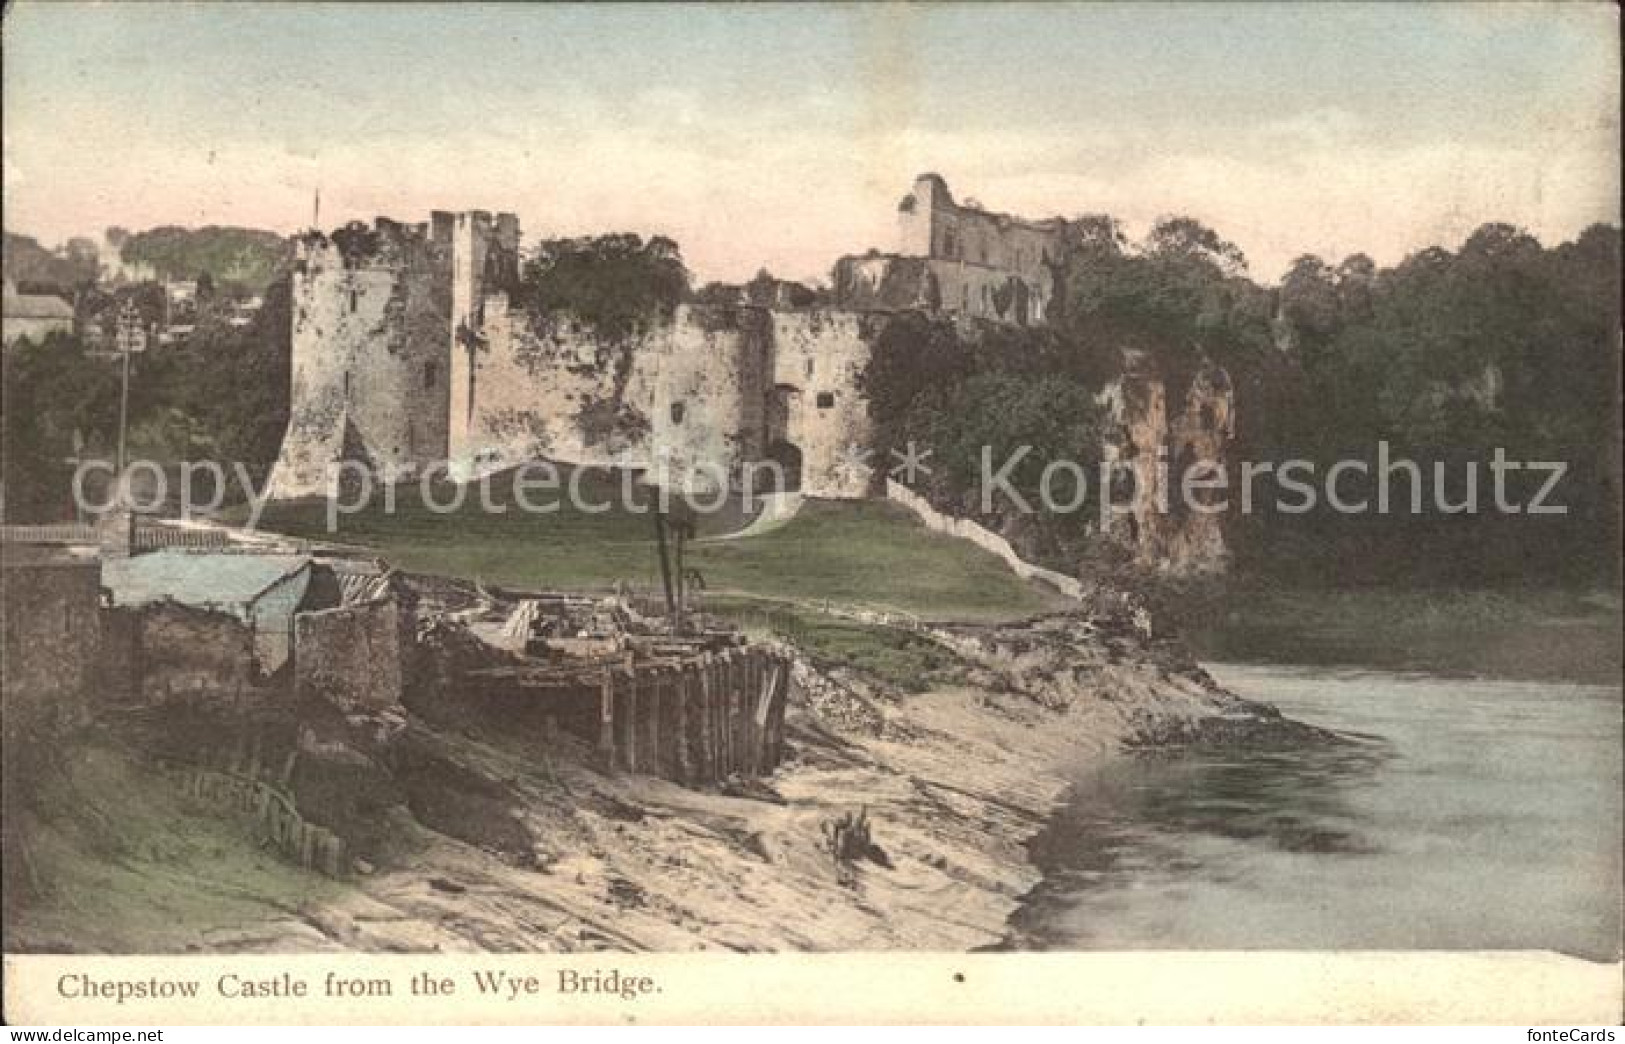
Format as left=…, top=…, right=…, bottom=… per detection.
left=866, top=215, right=1620, bottom=582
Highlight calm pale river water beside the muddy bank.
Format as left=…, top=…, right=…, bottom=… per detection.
left=1012, top=665, right=1622, bottom=959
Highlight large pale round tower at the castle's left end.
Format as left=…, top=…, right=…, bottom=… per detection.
left=271, top=220, right=452, bottom=498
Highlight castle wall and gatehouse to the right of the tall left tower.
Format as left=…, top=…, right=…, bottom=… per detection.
left=452, top=296, right=869, bottom=496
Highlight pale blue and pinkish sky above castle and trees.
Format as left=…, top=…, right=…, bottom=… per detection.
left=3, top=0, right=1620, bottom=280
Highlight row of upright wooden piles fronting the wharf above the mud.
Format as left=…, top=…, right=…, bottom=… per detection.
left=598, top=649, right=790, bottom=784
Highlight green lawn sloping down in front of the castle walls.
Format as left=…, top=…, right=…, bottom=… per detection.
left=250, top=478, right=1061, bottom=620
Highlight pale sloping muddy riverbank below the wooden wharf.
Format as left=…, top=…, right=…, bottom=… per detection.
left=13, top=604, right=1302, bottom=953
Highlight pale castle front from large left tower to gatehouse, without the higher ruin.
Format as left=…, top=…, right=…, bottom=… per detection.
left=271, top=211, right=871, bottom=498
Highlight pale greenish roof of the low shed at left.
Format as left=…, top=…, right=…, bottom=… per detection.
left=102, top=550, right=310, bottom=615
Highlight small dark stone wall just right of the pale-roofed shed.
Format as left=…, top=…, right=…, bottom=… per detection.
left=294, top=598, right=411, bottom=711
